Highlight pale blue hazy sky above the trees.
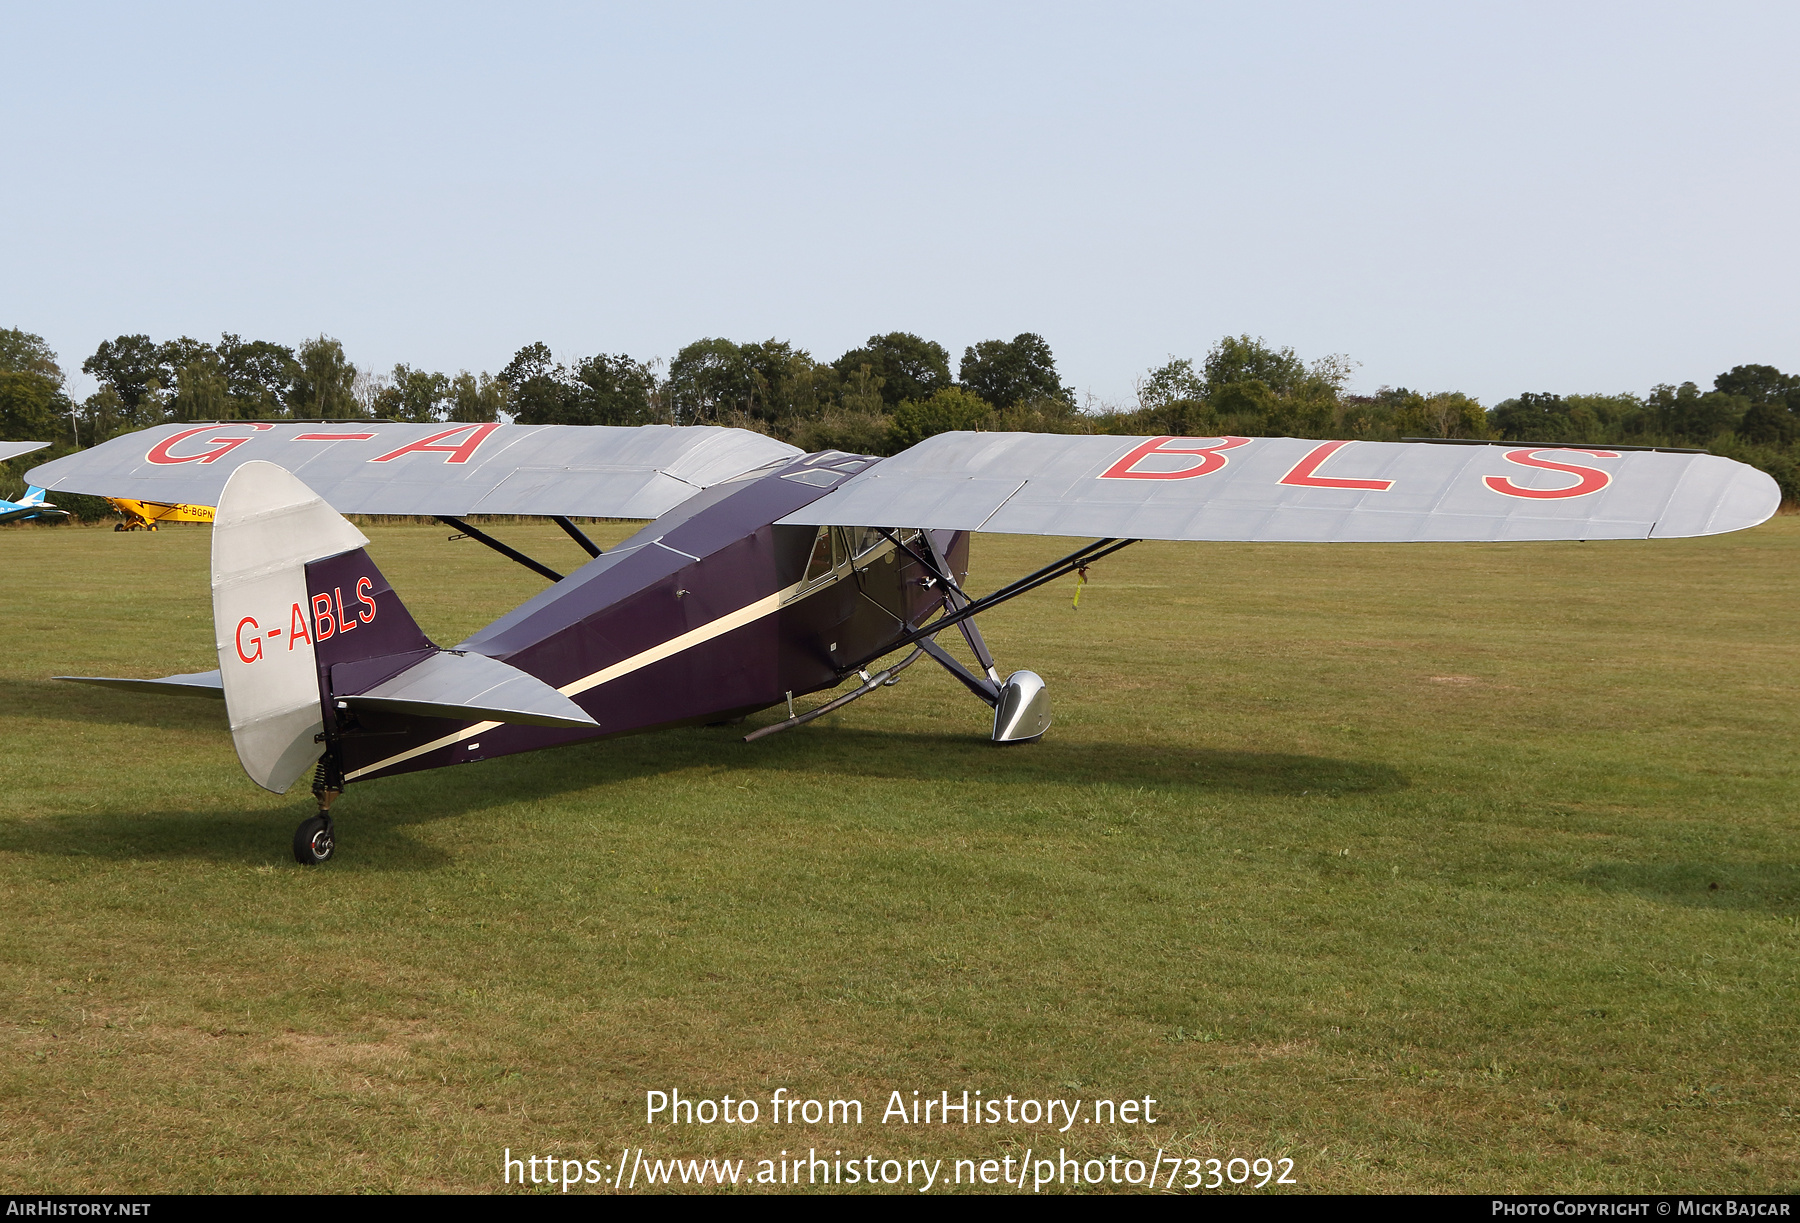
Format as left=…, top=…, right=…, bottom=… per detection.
left=0, top=2, right=1800, bottom=403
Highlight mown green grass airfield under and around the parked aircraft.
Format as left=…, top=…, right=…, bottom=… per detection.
left=0, top=517, right=1800, bottom=1192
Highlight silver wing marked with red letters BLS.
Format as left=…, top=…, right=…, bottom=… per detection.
left=781, top=432, right=1780, bottom=542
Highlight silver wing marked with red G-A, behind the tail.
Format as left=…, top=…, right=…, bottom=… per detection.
left=27, top=420, right=801, bottom=519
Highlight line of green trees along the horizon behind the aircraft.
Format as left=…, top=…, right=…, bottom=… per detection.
left=0, top=328, right=1800, bottom=501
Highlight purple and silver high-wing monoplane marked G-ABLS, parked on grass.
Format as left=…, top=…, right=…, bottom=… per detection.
left=29, top=421, right=1780, bottom=863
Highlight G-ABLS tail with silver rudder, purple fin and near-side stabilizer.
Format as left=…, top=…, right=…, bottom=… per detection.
left=212, top=461, right=594, bottom=794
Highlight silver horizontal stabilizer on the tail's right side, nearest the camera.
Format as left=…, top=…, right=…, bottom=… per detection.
left=337, top=650, right=598, bottom=728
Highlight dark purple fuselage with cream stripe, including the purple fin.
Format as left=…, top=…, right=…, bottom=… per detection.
left=308, top=452, right=968, bottom=780
